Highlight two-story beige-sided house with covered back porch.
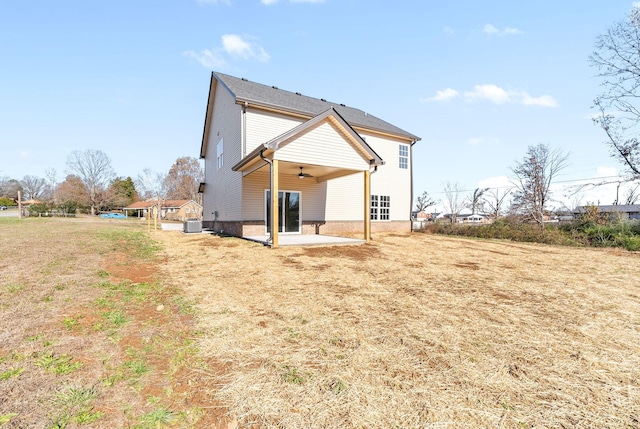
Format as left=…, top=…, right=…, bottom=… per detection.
left=200, top=72, right=420, bottom=247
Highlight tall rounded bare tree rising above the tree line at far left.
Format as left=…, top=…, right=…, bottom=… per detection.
left=67, top=149, right=115, bottom=215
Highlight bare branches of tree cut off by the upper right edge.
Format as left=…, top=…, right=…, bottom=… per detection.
left=589, top=7, right=640, bottom=178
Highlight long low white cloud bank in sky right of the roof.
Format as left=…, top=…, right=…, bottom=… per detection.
left=420, top=84, right=558, bottom=107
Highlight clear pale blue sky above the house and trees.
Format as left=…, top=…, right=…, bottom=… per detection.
left=0, top=0, right=633, bottom=211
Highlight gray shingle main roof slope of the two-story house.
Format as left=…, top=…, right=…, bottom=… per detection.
left=213, top=72, right=420, bottom=141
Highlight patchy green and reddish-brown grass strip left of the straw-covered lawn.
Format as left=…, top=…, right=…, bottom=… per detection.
left=0, top=218, right=227, bottom=429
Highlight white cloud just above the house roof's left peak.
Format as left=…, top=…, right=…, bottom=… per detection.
left=182, top=34, right=271, bottom=69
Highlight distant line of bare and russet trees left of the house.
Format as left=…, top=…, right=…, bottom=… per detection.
left=0, top=149, right=204, bottom=215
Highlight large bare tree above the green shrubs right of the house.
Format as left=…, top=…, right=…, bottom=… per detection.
left=511, top=143, right=569, bottom=231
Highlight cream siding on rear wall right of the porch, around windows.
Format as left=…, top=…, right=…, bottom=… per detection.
left=364, top=134, right=411, bottom=222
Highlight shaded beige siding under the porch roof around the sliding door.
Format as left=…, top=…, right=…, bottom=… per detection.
left=243, top=168, right=327, bottom=221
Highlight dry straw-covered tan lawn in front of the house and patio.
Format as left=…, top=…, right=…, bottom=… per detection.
left=154, top=232, right=640, bottom=428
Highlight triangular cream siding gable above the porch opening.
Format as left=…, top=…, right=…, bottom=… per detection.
left=274, top=122, right=369, bottom=170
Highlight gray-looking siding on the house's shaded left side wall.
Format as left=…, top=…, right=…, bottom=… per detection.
left=203, top=83, right=242, bottom=221
